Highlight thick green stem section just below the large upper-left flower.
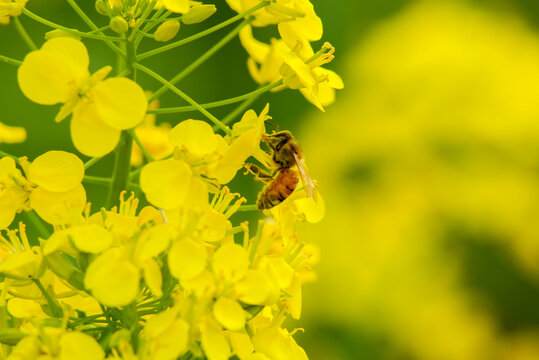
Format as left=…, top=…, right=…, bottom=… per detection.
left=107, top=130, right=133, bottom=208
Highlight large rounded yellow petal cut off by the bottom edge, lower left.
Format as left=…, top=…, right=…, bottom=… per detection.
left=58, top=331, right=105, bottom=360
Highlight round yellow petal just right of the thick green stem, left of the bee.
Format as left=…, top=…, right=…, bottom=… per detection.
left=140, top=159, right=192, bottom=209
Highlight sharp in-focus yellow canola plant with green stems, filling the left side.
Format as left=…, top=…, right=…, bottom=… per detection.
left=0, top=0, right=343, bottom=360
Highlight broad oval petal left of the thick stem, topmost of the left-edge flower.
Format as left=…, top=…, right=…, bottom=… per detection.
left=27, top=151, right=84, bottom=192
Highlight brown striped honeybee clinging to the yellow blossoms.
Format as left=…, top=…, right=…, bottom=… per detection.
left=245, top=131, right=316, bottom=210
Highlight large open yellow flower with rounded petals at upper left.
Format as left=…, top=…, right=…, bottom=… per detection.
left=18, top=37, right=147, bottom=156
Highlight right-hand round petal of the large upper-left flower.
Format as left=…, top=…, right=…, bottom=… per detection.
left=90, top=77, right=148, bottom=130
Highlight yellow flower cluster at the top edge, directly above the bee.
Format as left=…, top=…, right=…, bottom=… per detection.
left=227, top=0, right=344, bottom=110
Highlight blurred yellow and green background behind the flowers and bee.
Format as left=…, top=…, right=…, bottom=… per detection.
left=5, top=0, right=539, bottom=360
